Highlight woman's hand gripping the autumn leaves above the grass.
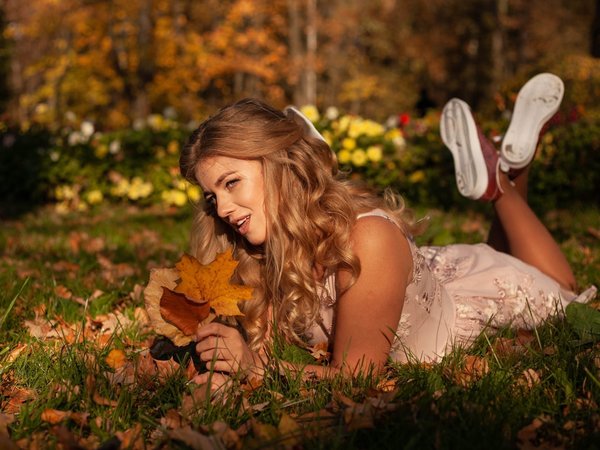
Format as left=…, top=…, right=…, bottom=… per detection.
left=196, top=322, right=264, bottom=376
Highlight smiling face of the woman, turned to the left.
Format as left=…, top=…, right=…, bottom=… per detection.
left=196, top=156, right=267, bottom=245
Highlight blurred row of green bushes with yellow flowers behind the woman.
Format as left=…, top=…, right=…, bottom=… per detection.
left=0, top=107, right=600, bottom=218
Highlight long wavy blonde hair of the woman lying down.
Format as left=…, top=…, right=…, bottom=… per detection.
left=179, top=99, right=416, bottom=349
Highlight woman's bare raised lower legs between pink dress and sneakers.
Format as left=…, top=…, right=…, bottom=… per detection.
left=492, top=169, right=576, bottom=291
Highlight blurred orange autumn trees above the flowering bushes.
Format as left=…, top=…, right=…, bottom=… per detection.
left=0, top=0, right=600, bottom=128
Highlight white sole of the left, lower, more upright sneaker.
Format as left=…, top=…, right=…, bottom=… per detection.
left=440, top=98, right=488, bottom=200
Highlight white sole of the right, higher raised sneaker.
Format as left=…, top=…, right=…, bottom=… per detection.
left=500, top=73, right=565, bottom=169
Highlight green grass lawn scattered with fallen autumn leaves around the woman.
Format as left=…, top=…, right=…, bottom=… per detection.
left=0, top=207, right=600, bottom=449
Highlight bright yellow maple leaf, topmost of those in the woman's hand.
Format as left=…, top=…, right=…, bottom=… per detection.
left=175, top=249, right=252, bottom=316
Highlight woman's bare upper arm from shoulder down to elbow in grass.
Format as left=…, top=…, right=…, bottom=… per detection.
left=332, top=216, right=413, bottom=373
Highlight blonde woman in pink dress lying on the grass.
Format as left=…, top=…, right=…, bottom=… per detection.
left=180, top=74, right=596, bottom=385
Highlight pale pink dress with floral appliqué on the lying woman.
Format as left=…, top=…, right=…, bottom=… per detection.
left=306, top=210, right=595, bottom=362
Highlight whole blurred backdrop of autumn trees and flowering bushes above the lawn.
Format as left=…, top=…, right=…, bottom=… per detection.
left=0, top=0, right=600, bottom=217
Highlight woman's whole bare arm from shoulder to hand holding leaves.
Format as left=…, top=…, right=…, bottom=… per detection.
left=196, top=216, right=412, bottom=383
